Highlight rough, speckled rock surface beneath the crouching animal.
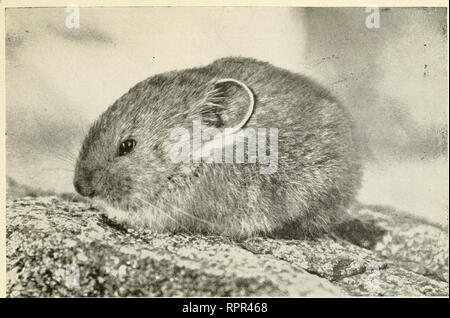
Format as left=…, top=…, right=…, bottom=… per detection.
left=6, top=197, right=449, bottom=297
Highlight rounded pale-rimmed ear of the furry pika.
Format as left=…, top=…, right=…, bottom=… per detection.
left=193, top=78, right=255, bottom=131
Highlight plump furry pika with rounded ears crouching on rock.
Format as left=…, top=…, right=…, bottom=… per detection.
left=74, top=57, right=361, bottom=238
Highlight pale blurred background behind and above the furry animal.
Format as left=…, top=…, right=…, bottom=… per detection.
left=6, top=7, right=448, bottom=224
